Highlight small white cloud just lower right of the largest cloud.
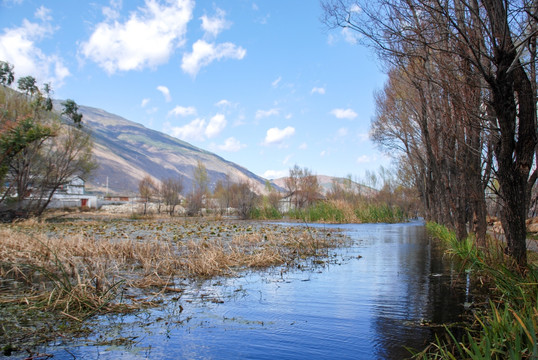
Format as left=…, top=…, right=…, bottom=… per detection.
left=181, top=40, right=247, bottom=77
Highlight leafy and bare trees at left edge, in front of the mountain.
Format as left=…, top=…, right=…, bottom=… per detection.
left=0, top=61, right=95, bottom=220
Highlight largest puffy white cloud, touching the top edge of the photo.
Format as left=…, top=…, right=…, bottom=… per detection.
left=80, top=0, right=194, bottom=74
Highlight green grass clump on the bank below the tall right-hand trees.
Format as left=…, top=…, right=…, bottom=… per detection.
left=416, top=224, right=538, bottom=360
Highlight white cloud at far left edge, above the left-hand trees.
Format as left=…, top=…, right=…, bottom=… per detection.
left=0, top=6, right=71, bottom=87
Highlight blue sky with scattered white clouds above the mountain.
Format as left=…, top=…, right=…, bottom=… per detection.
left=0, top=0, right=390, bottom=179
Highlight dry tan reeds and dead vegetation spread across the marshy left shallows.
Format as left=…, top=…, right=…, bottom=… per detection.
left=0, top=219, right=345, bottom=338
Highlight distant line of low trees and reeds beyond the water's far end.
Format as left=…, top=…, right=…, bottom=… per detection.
left=139, top=161, right=412, bottom=223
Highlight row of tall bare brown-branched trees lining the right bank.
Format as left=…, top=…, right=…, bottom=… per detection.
left=322, top=0, right=538, bottom=267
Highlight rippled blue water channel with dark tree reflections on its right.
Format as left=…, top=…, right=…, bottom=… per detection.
left=40, top=223, right=466, bottom=359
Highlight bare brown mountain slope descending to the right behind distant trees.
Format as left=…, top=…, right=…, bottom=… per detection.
left=72, top=105, right=266, bottom=195
